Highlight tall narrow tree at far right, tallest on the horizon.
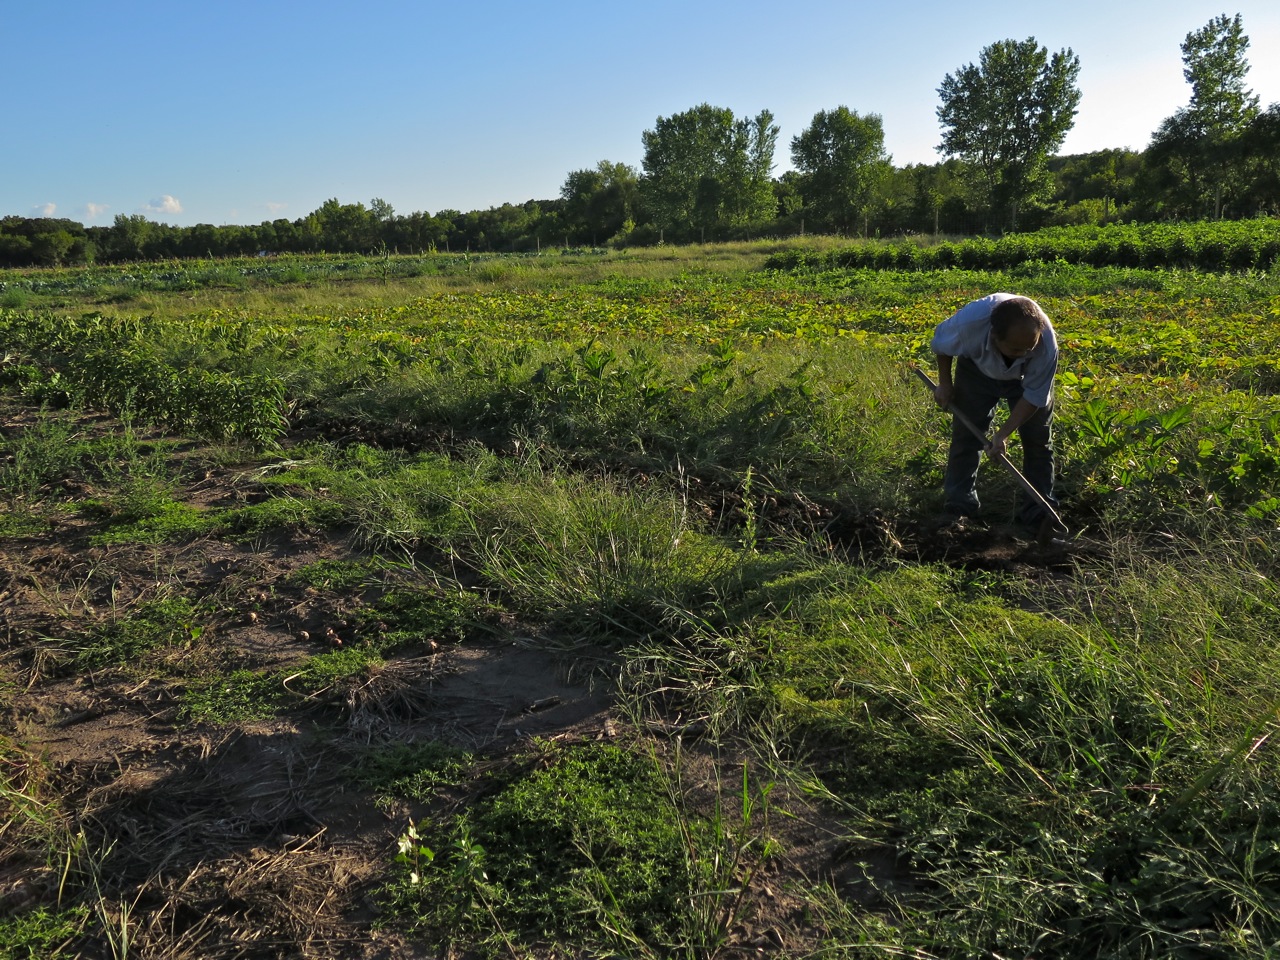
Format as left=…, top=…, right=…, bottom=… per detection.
left=1148, top=14, right=1258, bottom=219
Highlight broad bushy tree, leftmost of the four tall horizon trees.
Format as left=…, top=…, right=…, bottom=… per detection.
left=641, top=104, right=778, bottom=239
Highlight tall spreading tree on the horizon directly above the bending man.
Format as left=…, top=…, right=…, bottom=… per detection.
left=938, top=37, right=1080, bottom=228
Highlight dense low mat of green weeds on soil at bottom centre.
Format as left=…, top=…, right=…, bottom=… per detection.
left=390, top=746, right=689, bottom=942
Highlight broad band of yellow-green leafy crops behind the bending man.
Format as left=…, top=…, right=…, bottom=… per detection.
left=0, top=256, right=1280, bottom=527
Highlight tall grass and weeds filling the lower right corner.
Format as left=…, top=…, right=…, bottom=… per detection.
left=604, top=548, right=1280, bottom=957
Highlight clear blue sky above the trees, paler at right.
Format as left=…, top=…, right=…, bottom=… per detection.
left=0, top=0, right=1280, bottom=225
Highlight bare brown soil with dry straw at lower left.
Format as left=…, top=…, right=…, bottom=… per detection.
left=0, top=402, right=865, bottom=960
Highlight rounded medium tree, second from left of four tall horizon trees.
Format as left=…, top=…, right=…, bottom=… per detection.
left=791, top=106, right=891, bottom=233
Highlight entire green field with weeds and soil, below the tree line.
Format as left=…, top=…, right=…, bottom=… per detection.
left=0, top=239, right=1280, bottom=960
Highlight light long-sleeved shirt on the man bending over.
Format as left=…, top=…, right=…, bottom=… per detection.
left=929, top=293, right=1057, bottom=407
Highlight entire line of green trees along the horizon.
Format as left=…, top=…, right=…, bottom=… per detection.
left=0, top=14, right=1280, bottom=266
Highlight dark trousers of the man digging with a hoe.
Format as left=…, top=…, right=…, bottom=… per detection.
left=942, top=357, right=1057, bottom=525
